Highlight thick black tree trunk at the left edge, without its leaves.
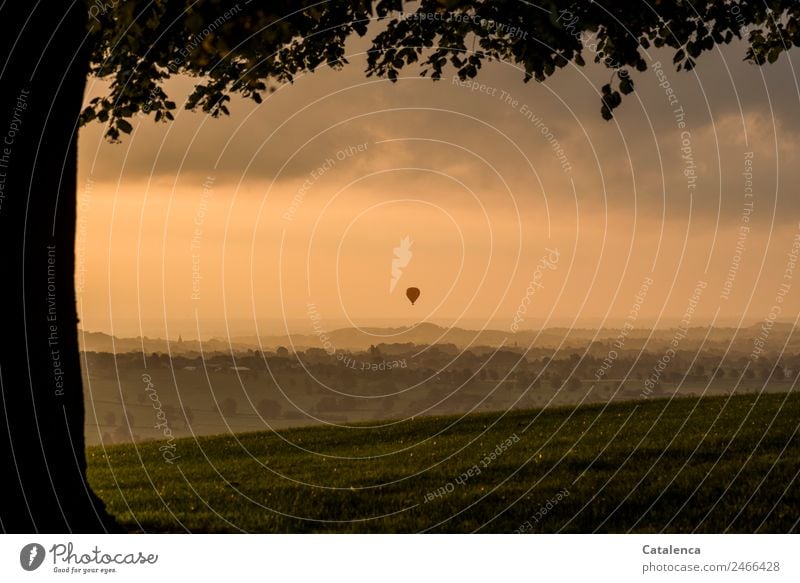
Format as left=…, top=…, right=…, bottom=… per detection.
left=0, top=0, right=118, bottom=532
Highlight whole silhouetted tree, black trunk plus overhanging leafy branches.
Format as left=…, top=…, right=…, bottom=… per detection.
left=0, top=0, right=800, bottom=532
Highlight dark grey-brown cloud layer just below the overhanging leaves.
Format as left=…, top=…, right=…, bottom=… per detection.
left=81, top=40, right=800, bottom=227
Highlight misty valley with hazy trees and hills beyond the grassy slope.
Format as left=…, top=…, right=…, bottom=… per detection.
left=82, top=324, right=800, bottom=448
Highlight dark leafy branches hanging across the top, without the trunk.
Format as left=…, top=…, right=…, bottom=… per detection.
left=81, top=0, right=800, bottom=140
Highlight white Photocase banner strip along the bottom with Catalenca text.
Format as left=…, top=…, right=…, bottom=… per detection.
left=0, top=535, right=800, bottom=583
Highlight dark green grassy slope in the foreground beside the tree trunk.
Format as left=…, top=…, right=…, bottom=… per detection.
left=88, top=393, right=800, bottom=533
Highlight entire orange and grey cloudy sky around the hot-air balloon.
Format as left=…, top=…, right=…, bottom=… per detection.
left=76, top=30, right=800, bottom=339
